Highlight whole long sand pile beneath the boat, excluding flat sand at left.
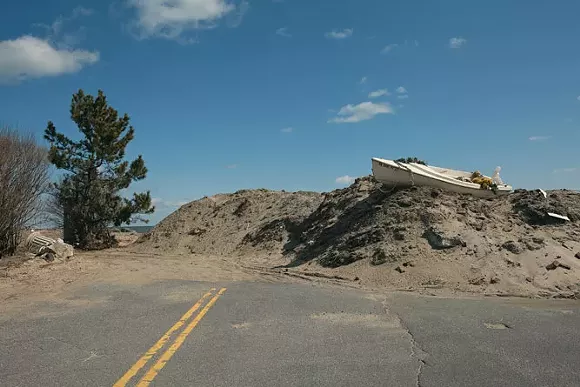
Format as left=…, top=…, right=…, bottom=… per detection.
left=139, top=177, right=580, bottom=298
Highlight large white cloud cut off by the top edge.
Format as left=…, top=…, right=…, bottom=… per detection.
left=128, top=0, right=238, bottom=39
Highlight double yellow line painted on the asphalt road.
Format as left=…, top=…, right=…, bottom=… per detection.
left=113, top=288, right=226, bottom=387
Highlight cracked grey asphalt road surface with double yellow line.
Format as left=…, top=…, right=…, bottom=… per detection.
left=0, top=281, right=580, bottom=387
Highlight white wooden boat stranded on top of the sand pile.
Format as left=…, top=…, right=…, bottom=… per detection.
left=372, top=157, right=512, bottom=198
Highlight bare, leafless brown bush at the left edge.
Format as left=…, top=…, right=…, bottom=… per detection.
left=0, top=127, right=50, bottom=258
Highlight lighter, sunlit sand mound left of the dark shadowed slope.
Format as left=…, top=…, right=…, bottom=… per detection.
left=134, top=189, right=323, bottom=256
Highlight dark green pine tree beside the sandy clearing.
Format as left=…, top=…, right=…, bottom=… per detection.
left=44, top=90, right=154, bottom=249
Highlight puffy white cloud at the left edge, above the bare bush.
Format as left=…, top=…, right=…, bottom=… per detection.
left=0, top=35, right=99, bottom=83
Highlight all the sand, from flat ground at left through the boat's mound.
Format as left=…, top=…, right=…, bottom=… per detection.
left=0, top=178, right=580, bottom=307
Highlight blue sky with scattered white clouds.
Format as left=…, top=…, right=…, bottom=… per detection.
left=0, top=0, right=580, bottom=222
